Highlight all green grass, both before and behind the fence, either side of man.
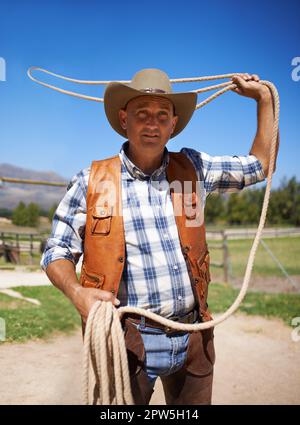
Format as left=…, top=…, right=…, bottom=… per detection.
left=0, top=237, right=300, bottom=342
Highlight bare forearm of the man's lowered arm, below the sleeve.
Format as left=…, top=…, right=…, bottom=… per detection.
left=46, top=259, right=81, bottom=304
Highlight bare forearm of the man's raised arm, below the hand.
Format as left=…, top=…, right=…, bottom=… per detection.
left=250, top=86, right=279, bottom=175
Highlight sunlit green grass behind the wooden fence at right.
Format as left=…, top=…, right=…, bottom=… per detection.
left=208, top=237, right=300, bottom=280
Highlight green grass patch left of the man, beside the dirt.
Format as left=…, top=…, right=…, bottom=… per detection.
left=0, top=286, right=80, bottom=342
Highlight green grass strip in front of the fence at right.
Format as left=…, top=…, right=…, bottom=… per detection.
left=208, top=283, right=300, bottom=325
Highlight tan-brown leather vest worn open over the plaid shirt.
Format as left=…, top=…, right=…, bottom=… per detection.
left=80, top=152, right=211, bottom=321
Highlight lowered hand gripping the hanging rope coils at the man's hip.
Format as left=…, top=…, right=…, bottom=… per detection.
left=72, top=286, right=120, bottom=322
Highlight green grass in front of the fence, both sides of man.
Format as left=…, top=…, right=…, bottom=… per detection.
left=0, top=283, right=300, bottom=344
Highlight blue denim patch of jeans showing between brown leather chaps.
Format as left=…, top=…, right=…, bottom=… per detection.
left=136, top=317, right=189, bottom=386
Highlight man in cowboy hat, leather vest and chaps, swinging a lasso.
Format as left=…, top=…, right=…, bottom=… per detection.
left=41, top=69, right=273, bottom=404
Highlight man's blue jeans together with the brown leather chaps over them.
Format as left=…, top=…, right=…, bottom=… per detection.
left=123, top=319, right=215, bottom=405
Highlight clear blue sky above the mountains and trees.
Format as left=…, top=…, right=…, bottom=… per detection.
left=0, top=0, right=300, bottom=185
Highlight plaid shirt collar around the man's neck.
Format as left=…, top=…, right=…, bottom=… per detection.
left=119, top=140, right=169, bottom=180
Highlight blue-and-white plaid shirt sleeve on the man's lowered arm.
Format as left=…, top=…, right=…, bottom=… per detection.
left=41, top=169, right=89, bottom=270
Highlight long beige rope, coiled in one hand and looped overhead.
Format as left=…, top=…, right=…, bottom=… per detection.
left=28, top=67, right=279, bottom=405
